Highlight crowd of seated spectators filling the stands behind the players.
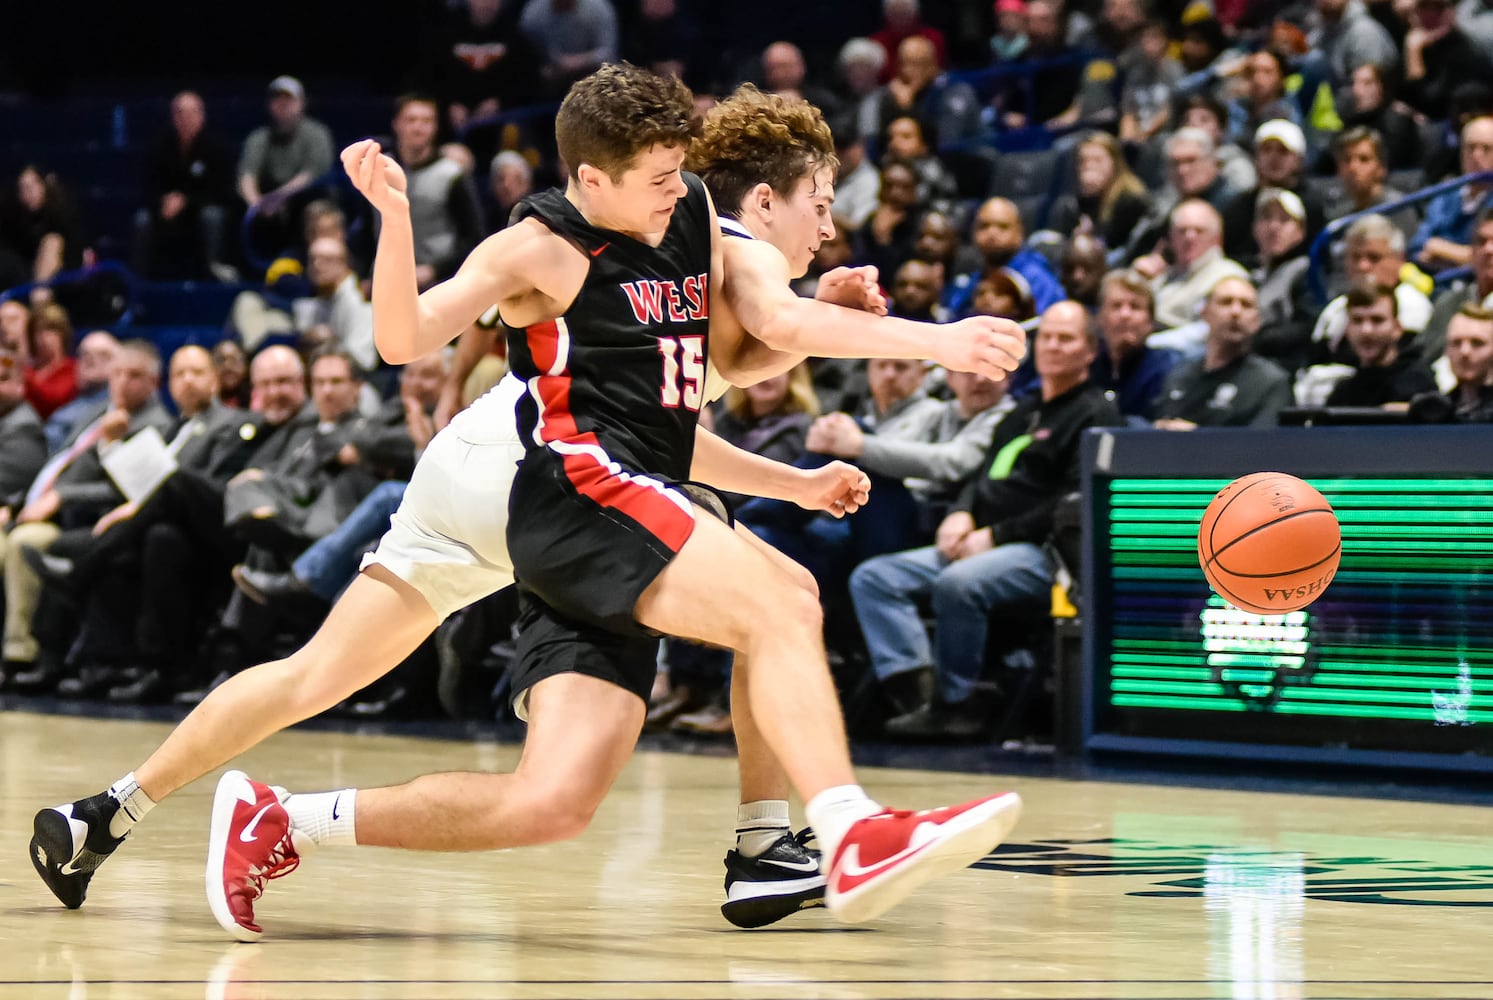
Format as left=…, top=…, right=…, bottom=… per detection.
left=0, top=0, right=1493, bottom=739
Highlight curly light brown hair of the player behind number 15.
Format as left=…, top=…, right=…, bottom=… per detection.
left=684, top=84, right=839, bottom=215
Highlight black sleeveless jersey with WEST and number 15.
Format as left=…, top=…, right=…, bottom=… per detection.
left=508, top=173, right=711, bottom=481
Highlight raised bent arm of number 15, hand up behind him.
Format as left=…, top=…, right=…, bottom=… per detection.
left=342, top=139, right=563, bottom=364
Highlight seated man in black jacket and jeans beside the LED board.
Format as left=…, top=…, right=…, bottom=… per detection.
left=850, top=301, right=1123, bottom=737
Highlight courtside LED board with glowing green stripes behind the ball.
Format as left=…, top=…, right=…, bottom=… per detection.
left=1076, top=427, right=1493, bottom=770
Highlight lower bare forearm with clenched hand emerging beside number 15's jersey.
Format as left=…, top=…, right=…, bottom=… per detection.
left=690, top=427, right=870, bottom=518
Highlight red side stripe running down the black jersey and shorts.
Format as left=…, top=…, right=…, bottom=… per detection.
left=524, top=322, right=694, bottom=552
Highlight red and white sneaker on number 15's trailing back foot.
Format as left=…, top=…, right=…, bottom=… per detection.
left=206, top=770, right=312, bottom=942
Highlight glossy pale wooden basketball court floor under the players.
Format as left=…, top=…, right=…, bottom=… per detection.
left=0, top=712, right=1493, bottom=1000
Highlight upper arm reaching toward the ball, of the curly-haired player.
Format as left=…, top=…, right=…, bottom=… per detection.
left=712, top=240, right=1026, bottom=384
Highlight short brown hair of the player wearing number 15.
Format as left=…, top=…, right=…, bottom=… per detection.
left=555, top=63, right=700, bottom=181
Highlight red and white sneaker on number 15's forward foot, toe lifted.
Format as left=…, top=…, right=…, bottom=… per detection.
left=824, top=791, right=1021, bottom=924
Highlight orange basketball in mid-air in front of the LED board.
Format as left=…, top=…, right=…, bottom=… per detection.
left=1197, top=472, right=1342, bottom=615
